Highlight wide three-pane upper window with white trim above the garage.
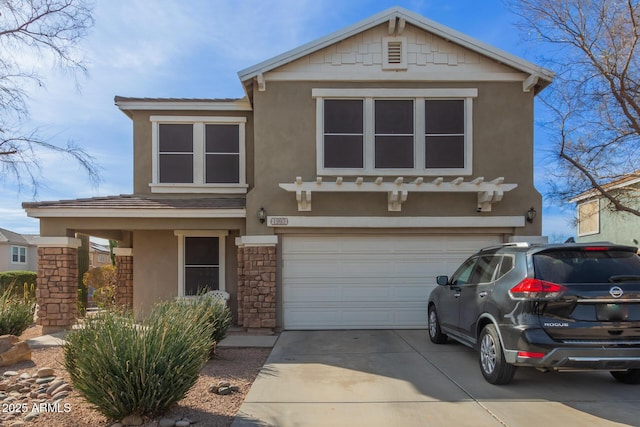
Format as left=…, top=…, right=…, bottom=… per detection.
left=313, top=89, right=477, bottom=175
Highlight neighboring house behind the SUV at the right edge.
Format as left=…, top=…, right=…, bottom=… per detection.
left=570, top=171, right=640, bottom=247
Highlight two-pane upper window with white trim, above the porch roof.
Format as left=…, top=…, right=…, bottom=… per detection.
left=150, top=116, right=247, bottom=193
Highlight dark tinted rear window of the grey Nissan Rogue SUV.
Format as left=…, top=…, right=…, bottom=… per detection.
left=533, top=249, right=640, bottom=283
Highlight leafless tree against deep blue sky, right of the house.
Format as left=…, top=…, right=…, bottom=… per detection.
left=507, top=0, right=640, bottom=216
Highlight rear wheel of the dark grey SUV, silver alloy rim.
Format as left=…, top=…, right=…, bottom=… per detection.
left=480, top=324, right=517, bottom=385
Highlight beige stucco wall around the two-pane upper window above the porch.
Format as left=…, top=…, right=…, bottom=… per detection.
left=129, top=110, right=253, bottom=194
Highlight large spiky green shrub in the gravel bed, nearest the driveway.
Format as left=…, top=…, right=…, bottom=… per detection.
left=64, top=302, right=213, bottom=419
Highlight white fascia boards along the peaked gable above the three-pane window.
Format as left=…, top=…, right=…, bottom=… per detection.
left=238, top=7, right=554, bottom=86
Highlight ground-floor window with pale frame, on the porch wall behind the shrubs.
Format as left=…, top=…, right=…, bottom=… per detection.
left=175, top=230, right=226, bottom=296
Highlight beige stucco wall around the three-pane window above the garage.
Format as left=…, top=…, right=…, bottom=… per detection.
left=247, top=81, right=542, bottom=235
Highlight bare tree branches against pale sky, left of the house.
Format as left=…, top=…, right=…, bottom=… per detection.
left=0, top=0, right=100, bottom=196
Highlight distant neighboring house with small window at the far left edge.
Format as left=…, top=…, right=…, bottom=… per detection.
left=0, top=228, right=38, bottom=272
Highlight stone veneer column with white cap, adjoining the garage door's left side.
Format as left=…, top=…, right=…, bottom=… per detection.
left=236, top=236, right=278, bottom=331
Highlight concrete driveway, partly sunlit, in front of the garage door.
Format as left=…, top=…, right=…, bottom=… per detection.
left=232, top=330, right=640, bottom=427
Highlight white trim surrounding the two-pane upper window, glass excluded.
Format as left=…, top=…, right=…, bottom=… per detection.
left=149, top=116, right=249, bottom=194
